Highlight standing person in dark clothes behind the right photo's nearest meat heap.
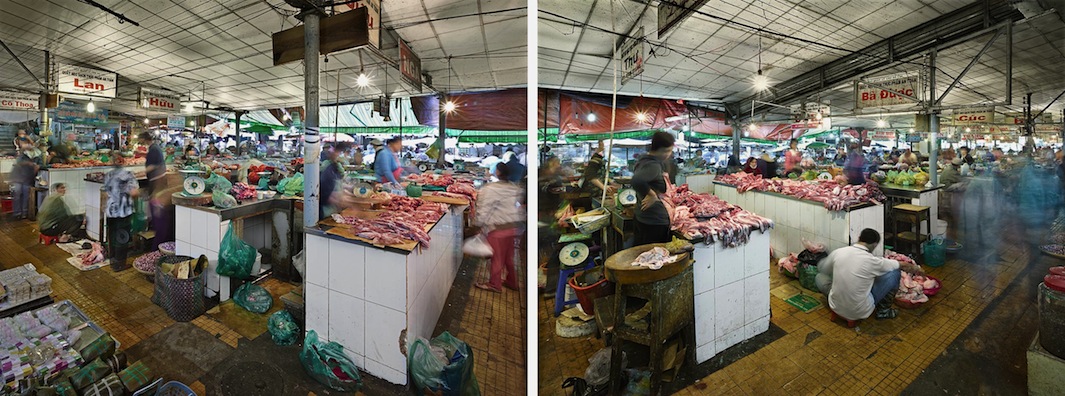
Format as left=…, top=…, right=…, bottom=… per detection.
left=633, top=132, right=675, bottom=246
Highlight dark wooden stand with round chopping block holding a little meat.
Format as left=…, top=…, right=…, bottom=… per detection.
left=606, top=244, right=695, bottom=395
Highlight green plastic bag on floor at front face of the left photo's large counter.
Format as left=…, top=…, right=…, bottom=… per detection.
left=299, top=330, right=362, bottom=392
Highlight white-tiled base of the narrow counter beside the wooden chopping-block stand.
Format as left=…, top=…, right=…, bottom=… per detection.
left=692, top=231, right=780, bottom=363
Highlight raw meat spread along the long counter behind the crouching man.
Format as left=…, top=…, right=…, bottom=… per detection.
left=716, top=171, right=886, bottom=211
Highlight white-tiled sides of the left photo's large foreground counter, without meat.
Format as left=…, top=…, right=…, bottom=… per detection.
left=305, top=207, right=465, bottom=384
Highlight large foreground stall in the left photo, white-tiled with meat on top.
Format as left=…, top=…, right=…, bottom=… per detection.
left=305, top=197, right=466, bottom=384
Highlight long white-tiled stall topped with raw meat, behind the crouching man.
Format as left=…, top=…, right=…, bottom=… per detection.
left=714, top=174, right=884, bottom=255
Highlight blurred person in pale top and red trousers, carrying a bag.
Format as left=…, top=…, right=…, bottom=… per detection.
left=474, top=163, right=525, bottom=293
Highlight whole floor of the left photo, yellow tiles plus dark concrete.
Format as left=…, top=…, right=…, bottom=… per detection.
left=0, top=217, right=527, bottom=396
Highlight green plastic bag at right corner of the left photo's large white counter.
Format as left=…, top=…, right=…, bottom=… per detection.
left=407, top=331, right=480, bottom=396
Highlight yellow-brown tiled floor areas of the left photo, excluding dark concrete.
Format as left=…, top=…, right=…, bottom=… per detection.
left=0, top=218, right=526, bottom=395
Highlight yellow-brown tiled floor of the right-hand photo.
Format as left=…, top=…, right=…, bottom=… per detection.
left=537, top=227, right=1045, bottom=395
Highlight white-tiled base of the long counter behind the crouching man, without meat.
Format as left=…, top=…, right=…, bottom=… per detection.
left=714, top=182, right=884, bottom=257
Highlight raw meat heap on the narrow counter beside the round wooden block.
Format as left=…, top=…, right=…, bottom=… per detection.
left=661, top=179, right=773, bottom=247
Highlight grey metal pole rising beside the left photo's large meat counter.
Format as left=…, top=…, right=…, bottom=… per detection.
left=301, top=9, right=323, bottom=227
